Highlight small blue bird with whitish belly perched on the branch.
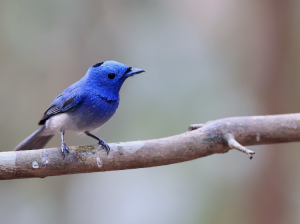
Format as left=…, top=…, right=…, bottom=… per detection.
left=14, top=61, right=144, bottom=157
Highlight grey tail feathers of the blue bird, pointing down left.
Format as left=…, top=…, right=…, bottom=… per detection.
left=14, top=125, right=54, bottom=151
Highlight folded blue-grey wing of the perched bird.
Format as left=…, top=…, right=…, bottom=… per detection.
left=39, top=88, right=82, bottom=125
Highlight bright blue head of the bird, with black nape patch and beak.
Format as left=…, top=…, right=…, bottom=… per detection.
left=83, top=61, right=144, bottom=98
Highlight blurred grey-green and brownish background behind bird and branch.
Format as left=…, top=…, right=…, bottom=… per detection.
left=0, top=0, right=300, bottom=224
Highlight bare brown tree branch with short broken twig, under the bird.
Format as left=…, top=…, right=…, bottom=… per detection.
left=0, top=114, right=300, bottom=180
